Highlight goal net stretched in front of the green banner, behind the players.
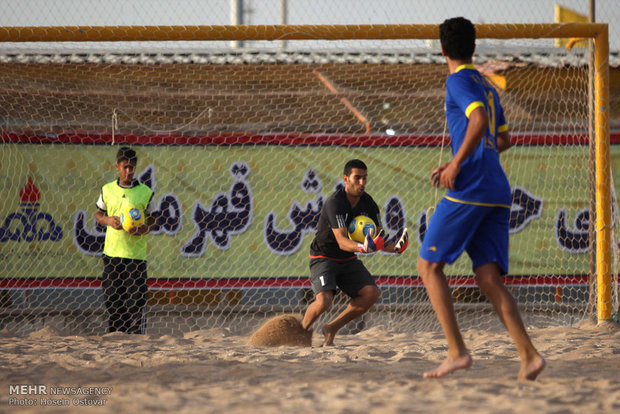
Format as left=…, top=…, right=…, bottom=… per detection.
left=0, top=25, right=620, bottom=334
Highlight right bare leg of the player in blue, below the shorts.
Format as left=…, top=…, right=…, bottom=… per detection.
left=474, top=263, right=546, bottom=380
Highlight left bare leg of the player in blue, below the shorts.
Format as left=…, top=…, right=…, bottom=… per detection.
left=418, top=258, right=472, bottom=378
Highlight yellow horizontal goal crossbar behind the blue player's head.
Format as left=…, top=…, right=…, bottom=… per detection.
left=0, top=23, right=608, bottom=42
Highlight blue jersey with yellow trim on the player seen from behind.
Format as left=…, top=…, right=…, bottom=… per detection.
left=445, top=64, right=512, bottom=208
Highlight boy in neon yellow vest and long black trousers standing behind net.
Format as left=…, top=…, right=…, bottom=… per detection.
left=95, top=147, right=155, bottom=334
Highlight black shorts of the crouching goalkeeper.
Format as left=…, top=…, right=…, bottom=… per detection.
left=310, top=258, right=377, bottom=298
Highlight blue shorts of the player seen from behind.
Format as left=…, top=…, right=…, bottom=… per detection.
left=420, top=198, right=510, bottom=274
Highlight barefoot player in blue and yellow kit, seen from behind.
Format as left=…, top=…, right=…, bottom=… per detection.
left=417, top=17, right=545, bottom=380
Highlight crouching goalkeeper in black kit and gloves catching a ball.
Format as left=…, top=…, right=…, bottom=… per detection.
left=302, top=160, right=409, bottom=346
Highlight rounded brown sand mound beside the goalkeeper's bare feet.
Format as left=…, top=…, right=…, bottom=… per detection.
left=248, top=315, right=312, bottom=346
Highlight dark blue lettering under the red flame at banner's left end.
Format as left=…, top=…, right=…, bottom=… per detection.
left=0, top=203, right=63, bottom=242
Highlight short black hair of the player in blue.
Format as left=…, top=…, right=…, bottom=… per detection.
left=439, top=17, right=476, bottom=60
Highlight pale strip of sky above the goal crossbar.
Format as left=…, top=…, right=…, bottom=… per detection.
left=0, top=0, right=620, bottom=51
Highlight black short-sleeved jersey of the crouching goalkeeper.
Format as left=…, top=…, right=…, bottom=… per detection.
left=310, top=187, right=382, bottom=259
